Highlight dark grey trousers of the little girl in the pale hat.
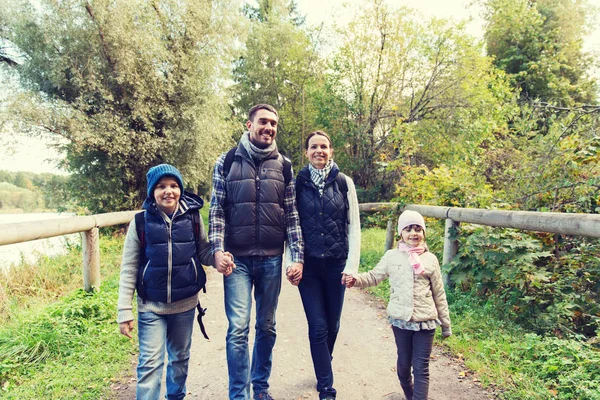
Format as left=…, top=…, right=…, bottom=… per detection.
left=392, top=326, right=435, bottom=400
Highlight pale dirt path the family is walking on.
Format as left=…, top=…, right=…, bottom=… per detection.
left=113, top=269, right=493, bottom=400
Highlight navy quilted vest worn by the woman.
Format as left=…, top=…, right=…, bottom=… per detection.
left=296, top=165, right=348, bottom=259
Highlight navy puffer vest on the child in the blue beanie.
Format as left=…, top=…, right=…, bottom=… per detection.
left=137, top=193, right=206, bottom=303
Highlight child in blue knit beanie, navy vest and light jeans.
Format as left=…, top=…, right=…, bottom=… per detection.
left=117, top=164, right=233, bottom=400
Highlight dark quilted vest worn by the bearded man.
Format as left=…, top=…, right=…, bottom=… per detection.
left=225, top=144, right=286, bottom=256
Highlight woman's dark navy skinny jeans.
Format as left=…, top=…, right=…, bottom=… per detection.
left=298, top=257, right=346, bottom=398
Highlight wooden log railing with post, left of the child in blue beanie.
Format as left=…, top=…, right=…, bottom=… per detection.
left=0, top=211, right=139, bottom=292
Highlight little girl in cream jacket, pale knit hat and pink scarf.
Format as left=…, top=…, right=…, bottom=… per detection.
left=344, top=210, right=452, bottom=400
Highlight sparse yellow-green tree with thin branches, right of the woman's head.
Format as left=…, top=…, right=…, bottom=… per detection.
left=321, top=0, right=511, bottom=200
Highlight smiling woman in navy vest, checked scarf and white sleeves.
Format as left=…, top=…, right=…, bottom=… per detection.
left=296, top=131, right=360, bottom=399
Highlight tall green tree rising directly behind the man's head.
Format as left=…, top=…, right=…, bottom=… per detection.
left=233, top=0, right=322, bottom=167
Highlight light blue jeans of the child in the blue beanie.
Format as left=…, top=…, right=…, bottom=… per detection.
left=135, top=308, right=196, bottom=400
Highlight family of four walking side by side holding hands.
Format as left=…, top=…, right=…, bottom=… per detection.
left=117, top=104, right=451, bottom=400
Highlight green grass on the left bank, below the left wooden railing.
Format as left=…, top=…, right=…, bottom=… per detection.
left=0, top=236, right=137, bottom=399
